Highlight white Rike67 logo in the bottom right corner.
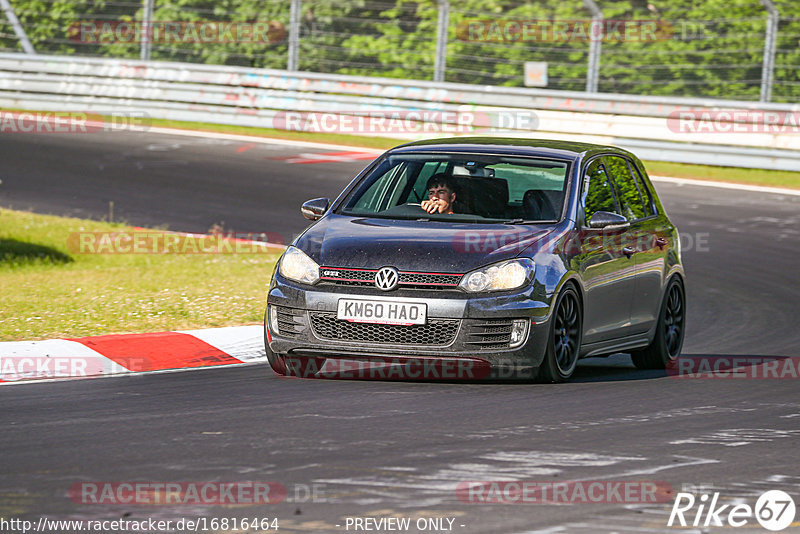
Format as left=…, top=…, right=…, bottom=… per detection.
left=667, top=490, right=796, bottom=532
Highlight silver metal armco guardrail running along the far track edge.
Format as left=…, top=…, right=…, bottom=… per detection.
left=0, top=54, right=800, bottom=170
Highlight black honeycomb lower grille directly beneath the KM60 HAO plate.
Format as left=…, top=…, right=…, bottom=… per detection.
left=309, top=312, right=461, bottom=345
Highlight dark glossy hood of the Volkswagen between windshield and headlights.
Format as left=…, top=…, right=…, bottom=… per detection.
left=295, top=214, right=552, bottom=273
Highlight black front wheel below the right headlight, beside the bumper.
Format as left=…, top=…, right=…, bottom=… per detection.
left=536, top=286, right=583, bottom=383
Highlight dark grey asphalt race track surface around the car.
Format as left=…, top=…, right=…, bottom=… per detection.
left=0, top=133, right=800, bottom=534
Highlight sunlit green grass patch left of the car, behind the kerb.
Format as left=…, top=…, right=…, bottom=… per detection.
left=0, top=209, right=279, bottom=341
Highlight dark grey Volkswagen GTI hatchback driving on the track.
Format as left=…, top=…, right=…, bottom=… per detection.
left=264, top=138, right=686, bottom=382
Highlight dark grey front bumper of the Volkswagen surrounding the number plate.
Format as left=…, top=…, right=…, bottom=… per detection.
left=265, top=275, right=550, bottom=380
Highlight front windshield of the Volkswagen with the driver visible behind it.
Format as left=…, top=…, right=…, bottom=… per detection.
left=337, top=153, right=570, bottom=223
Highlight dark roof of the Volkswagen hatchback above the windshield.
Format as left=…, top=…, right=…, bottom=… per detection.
left=389, top=137, right=633, bottom=160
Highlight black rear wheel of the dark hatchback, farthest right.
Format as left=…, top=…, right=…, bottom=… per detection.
left=631, top=278, right=686, bottom=369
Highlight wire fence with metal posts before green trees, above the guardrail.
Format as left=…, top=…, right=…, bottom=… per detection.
left=0, top=0, right=800, bottom=102
